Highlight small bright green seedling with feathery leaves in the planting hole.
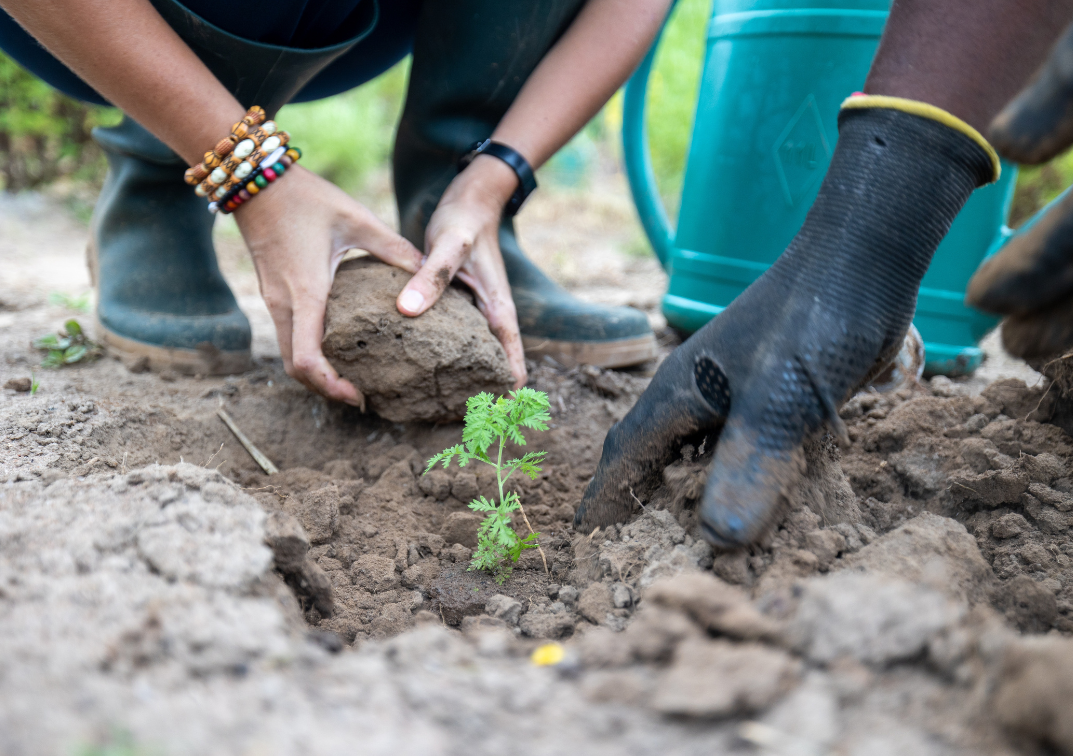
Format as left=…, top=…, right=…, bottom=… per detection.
left=425, top=388, right=550, bottom=584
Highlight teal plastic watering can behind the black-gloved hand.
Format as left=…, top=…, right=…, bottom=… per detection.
left=622, top=0, right=1017, bottom=375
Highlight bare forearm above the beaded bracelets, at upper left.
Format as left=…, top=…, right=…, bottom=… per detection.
left=0, top=0, right=245, bottom=164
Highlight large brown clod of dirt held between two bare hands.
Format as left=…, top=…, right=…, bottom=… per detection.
left=322, top=257, right=514, bottom=423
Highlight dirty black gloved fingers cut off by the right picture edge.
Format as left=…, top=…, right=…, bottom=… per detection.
left=966, top=19, right=1073, bottom=364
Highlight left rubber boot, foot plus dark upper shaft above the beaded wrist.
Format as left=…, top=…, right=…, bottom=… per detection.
left=88, top=0, right=376, bottom=375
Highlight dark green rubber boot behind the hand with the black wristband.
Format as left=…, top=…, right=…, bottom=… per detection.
left=394, top=0, right=656, bottom=368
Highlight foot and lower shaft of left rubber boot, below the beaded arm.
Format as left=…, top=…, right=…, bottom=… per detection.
left=89, top=117, right=250, bottom=375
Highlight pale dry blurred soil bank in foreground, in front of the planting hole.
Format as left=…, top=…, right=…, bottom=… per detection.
left=6, top=464, right=1073, bottom=756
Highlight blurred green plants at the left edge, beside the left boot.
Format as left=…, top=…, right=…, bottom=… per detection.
left=0, top=53, right=119, bottom=192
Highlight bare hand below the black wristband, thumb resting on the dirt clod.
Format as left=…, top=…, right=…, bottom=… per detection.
left=397, top=155, right=527, bottom=387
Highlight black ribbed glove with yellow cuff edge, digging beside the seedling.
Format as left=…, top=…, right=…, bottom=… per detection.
left=575, top=97, right=998, bottom=547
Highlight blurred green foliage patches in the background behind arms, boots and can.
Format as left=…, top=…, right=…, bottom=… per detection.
left=0, top=0, right=1073, bottom=232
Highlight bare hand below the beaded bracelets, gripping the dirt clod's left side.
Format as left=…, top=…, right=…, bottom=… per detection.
left=234, top=165, right=422, bottom=410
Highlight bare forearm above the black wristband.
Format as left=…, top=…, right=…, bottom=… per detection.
left=493, top=0, right=671, bottom=167
